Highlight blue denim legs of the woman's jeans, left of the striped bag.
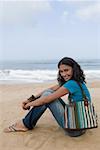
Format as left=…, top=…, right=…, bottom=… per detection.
left=23, top=89, right=65, bottom=129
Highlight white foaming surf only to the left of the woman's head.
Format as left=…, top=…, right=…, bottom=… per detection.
left=0, top=70, right=57, bottom=83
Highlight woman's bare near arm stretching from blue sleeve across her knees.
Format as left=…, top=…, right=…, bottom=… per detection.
left=26, top=86, right=69, bottom=108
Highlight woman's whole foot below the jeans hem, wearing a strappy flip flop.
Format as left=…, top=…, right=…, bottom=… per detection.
left=4, top=120, right=29, bottom=133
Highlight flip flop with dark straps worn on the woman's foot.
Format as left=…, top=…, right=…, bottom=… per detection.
left=4, top=124, right=27, bottom=133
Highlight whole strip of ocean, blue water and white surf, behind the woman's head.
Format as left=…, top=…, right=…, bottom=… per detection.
left=0, top=59, right=100, bottom=84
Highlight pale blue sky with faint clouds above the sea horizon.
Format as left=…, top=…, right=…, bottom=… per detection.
left=0, top=0, right=100, bottom=61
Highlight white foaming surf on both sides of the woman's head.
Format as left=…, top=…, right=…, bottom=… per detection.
left=0, top=69, right=100, bottom=83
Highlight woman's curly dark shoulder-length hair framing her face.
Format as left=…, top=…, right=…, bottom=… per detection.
left=57, top=57, right=86, bottom=85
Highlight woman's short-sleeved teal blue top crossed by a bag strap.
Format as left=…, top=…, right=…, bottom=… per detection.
left=63, top=80, right=91, bottom=102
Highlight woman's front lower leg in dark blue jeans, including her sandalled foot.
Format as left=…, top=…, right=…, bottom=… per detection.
left=4, top=89, right=48, bottom=132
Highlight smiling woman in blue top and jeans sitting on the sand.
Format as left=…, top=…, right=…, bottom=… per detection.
left=4, top=57, right=91, bottom=137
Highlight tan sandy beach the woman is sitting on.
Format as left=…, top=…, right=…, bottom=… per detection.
left=0, top=81, right=100, bottom=150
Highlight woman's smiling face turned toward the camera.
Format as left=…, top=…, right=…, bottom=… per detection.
left=59, top=65, right=73, bottom=81
